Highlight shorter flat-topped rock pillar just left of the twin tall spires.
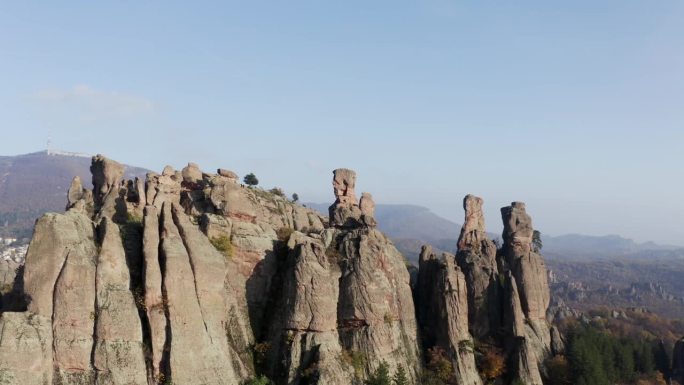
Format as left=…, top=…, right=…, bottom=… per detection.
left=416, top=246, right=482, bottom=385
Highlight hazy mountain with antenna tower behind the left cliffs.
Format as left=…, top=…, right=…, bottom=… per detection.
left=0, top=151, right=148, bottom=238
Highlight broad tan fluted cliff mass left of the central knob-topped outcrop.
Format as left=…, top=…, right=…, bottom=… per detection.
left=0, top=156, right=334, bottom=385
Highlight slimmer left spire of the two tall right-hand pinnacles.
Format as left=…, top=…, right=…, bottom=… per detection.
left=456, top=195, right=501, bottom=338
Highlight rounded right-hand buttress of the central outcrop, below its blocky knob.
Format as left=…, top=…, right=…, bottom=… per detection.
left=336, top=228, right=420, bottom=379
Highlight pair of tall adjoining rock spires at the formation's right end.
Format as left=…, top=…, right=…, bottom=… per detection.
left=457, top=195, right=562, bottom=385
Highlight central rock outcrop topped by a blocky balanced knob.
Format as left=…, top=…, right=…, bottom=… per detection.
left=260, top=170, right=421, bottom=385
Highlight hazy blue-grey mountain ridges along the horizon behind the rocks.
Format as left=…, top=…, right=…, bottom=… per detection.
left=0, top=151, right=684, bottom=260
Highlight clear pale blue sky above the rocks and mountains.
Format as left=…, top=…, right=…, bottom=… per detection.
left=0, top=0, right=684, bottom=244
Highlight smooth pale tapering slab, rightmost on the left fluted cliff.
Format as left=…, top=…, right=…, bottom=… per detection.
left=160, top=202, right=239, bottom=384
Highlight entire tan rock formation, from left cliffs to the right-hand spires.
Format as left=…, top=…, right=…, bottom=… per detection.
left=0, top=156, right=550, bottom=385
